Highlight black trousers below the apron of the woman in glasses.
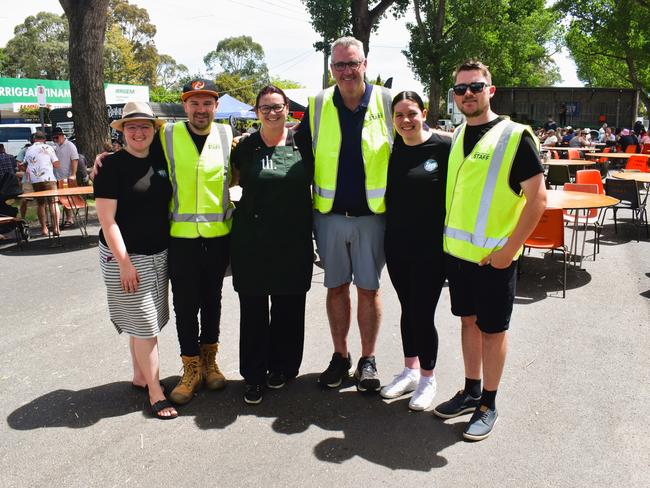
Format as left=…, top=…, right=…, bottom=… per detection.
left=239, top=293, right=307, bottom=385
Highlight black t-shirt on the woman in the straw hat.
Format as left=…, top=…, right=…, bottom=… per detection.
left=94, top=149, right=172, bottom=255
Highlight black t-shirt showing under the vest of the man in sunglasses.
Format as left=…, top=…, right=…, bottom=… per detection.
left=463, top=117, right=544, bottom=194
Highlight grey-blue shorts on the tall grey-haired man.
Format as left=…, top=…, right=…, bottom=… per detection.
left=314, top=211, right=386, bottom=290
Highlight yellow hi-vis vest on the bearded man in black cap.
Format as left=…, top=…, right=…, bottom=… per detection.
left=160, top=122, right=234, bottom=239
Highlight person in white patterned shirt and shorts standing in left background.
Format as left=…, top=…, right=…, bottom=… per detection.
left=24, top=131, right=60, bottom=236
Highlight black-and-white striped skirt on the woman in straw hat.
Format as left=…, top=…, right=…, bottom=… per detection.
left=99, top=242, right=169, bottom=339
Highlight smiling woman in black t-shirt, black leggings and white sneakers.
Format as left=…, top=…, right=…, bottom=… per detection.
left=380, top=91, right=451, bottom=410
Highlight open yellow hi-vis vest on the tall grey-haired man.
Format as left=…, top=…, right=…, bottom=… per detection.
left=309, top=85, right=393, bottom=214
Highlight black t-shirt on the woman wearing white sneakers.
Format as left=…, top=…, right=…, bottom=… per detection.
left=385, top=132, right=451, bottom=259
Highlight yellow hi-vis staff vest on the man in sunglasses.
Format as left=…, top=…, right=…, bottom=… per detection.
left=443, top=119, right=539, bottom=263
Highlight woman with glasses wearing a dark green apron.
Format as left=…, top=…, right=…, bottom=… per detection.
left=231, top=86, right=313, bottom=404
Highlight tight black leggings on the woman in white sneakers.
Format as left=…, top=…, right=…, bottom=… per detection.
left=386, top=255, right=445, bottom=371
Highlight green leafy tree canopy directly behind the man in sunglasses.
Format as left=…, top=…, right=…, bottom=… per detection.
left=404, top=0, right=560, bottom=122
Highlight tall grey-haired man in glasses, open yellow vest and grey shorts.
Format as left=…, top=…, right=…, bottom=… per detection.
left=296, top=37, right=393, bottom=392
